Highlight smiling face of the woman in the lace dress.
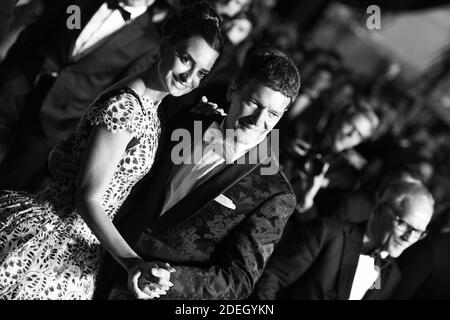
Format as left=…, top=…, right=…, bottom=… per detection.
left=158, top=36, right=219, bottom=97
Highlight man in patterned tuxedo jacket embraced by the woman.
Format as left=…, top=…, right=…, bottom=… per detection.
left=92, top=50, right=300, bottom=299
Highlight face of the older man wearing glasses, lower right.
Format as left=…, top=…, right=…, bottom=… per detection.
left=372, top=196, right=433, bottom=258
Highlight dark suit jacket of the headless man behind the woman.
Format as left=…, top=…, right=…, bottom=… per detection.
left=0, top=0, right=160, bottom=187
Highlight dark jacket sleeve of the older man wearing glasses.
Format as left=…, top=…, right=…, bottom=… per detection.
left=254, top=219, right=326, bottom=300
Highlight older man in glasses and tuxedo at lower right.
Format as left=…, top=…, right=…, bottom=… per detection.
left=254, top=180, right=434, bottom=300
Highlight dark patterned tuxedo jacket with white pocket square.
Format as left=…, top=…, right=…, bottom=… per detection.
left=97, top=109, right=296, bottom=299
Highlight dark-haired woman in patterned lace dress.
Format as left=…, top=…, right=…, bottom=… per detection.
left=0, top=5, right=222, bottom=299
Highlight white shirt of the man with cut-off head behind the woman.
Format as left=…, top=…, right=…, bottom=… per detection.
left=72, top=2, right=147, bottom=57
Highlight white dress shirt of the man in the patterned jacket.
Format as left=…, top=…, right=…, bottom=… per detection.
left=161, top=122, right=265, bottom=214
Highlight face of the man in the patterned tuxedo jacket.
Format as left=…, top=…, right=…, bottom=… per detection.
left=225, top=80, right=291, bottom=144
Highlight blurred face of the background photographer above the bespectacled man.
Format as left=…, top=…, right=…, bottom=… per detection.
left=331, top=114, right=372, bottom=153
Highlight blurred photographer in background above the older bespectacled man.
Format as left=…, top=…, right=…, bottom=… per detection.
left=281, top=102, right=379, bottom=220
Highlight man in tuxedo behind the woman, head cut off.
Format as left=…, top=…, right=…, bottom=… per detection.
left=0, top=0, right=159, bottom=190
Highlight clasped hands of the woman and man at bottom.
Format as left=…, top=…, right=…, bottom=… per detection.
left=128, top=260, right=175, bottom=300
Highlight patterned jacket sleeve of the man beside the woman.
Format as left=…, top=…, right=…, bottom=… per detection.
left=157, top=194, right=296, bottom=299
